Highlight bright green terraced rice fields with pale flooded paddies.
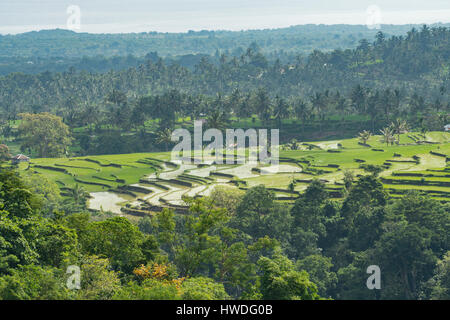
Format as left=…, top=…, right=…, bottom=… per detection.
left=16, top=132, right=450, bottom=216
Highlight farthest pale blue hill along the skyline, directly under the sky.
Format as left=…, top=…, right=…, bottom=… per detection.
left=0, top=24, right=450, bottom=58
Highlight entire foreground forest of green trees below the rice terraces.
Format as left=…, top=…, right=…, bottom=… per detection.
left=0, top=169, right=450, bottom=300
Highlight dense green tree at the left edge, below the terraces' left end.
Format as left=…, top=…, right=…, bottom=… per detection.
left=0, top=170, right=77, bottom=272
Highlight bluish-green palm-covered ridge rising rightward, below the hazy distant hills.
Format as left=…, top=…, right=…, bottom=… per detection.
left=0, top=27, right=450, bottom=118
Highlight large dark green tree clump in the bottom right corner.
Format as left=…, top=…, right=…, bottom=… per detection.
left=337, top=193, right=450, bottom=299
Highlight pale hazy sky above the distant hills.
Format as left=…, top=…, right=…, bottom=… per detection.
left=0, top=0, right=450, bottom=34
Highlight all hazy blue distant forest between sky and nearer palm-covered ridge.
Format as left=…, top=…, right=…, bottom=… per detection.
left=0, top=24, right=447, bottom=75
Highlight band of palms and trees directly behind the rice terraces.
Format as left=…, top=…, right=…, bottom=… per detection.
left=1, top=85, right=449, bottom=157
